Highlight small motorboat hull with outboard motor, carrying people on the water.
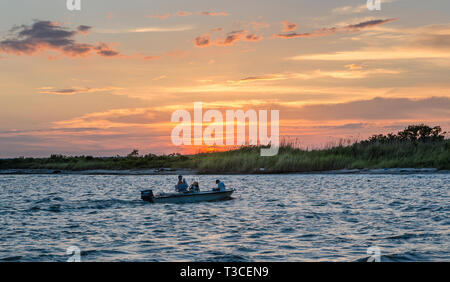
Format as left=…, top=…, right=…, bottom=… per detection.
left=141, top=189, right=234, bottom=203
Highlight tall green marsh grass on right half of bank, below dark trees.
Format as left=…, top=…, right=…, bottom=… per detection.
left=191, top=140, right=450, bottom=173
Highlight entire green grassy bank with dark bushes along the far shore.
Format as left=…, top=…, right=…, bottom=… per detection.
left=0, top=125, right=450, bottom=173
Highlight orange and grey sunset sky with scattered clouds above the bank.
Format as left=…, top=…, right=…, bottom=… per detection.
left=0, top=0, right=450, bottom=158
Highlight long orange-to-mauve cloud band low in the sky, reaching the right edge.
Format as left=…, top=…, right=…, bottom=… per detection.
left=54, top=97, right=450, bottom=133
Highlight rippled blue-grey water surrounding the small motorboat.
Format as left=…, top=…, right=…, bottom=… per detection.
left=0, top=174, right=450, bottom=261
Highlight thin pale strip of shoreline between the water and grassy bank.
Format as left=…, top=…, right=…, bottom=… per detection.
left=0, top=168, right=450, bottom=175
